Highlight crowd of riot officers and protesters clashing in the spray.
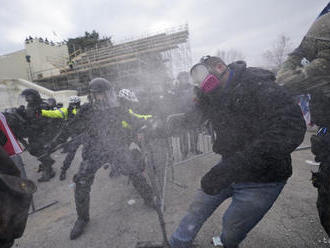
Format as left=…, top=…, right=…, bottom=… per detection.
left=0, top=4, right=330, bottom=248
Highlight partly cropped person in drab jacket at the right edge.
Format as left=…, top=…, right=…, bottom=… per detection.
left=277, top=3, right=330, bottom=237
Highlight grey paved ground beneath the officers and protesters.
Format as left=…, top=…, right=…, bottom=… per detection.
left=14, top=134, right=330, bottom=248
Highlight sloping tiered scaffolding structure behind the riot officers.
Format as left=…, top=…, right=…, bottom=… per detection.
left=37, top=25, right=192, bottom=93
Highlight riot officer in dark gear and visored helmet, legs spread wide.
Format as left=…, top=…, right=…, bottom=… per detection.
left=64, top=78, right=153, bottom=239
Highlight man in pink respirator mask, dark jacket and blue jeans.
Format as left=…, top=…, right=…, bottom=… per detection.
left=168, top=56, right=306, bottom=248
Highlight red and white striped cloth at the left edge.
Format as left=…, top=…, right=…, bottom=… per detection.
left=0, top=113, right=23, bottom=156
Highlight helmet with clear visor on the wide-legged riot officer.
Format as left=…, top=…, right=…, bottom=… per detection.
left=88, top=78, right=119, bottom=109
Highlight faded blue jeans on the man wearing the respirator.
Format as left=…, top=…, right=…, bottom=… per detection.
left=170, top=182, right=286, bottom=248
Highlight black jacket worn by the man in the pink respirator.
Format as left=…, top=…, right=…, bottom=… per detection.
left=187, top=61, right=306, bottom=186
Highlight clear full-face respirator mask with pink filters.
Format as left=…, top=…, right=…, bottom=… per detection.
left=190, top=63, right=226, bottom=93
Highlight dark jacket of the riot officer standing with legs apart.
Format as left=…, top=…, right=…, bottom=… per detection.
left=63, top=103, right=148, bottom=161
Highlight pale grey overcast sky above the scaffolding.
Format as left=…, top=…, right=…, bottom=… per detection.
left=0, top=0, right=329, bottom=65
